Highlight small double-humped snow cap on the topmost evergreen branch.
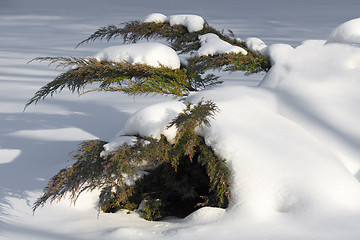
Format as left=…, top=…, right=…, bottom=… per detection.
left=144, top=13, right=205, bottom=32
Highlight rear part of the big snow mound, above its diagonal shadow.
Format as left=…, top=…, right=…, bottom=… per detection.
left=260, top=41, right=360, bottom=174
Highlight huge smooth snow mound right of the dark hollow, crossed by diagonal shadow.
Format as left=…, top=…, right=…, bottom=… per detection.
left=189, top=39, right=360, bottom=219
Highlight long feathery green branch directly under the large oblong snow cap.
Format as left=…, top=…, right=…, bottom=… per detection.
left=25, top=57, right=191, bottom=108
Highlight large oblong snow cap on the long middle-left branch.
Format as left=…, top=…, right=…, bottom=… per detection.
left=95, top=42, right=180, bottom=69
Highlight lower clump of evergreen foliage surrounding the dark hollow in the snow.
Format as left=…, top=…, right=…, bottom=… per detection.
left=33, top=101, right=230, bottom=220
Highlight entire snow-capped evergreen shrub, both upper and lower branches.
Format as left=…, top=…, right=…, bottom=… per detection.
left=26, top=14, right=270, bottom=220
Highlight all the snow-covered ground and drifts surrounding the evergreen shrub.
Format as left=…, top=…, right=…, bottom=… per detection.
left=0, top=0, right=360, bottom=240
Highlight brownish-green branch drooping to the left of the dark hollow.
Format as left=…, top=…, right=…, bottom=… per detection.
left=33, top=139, right=158, bottom=211
